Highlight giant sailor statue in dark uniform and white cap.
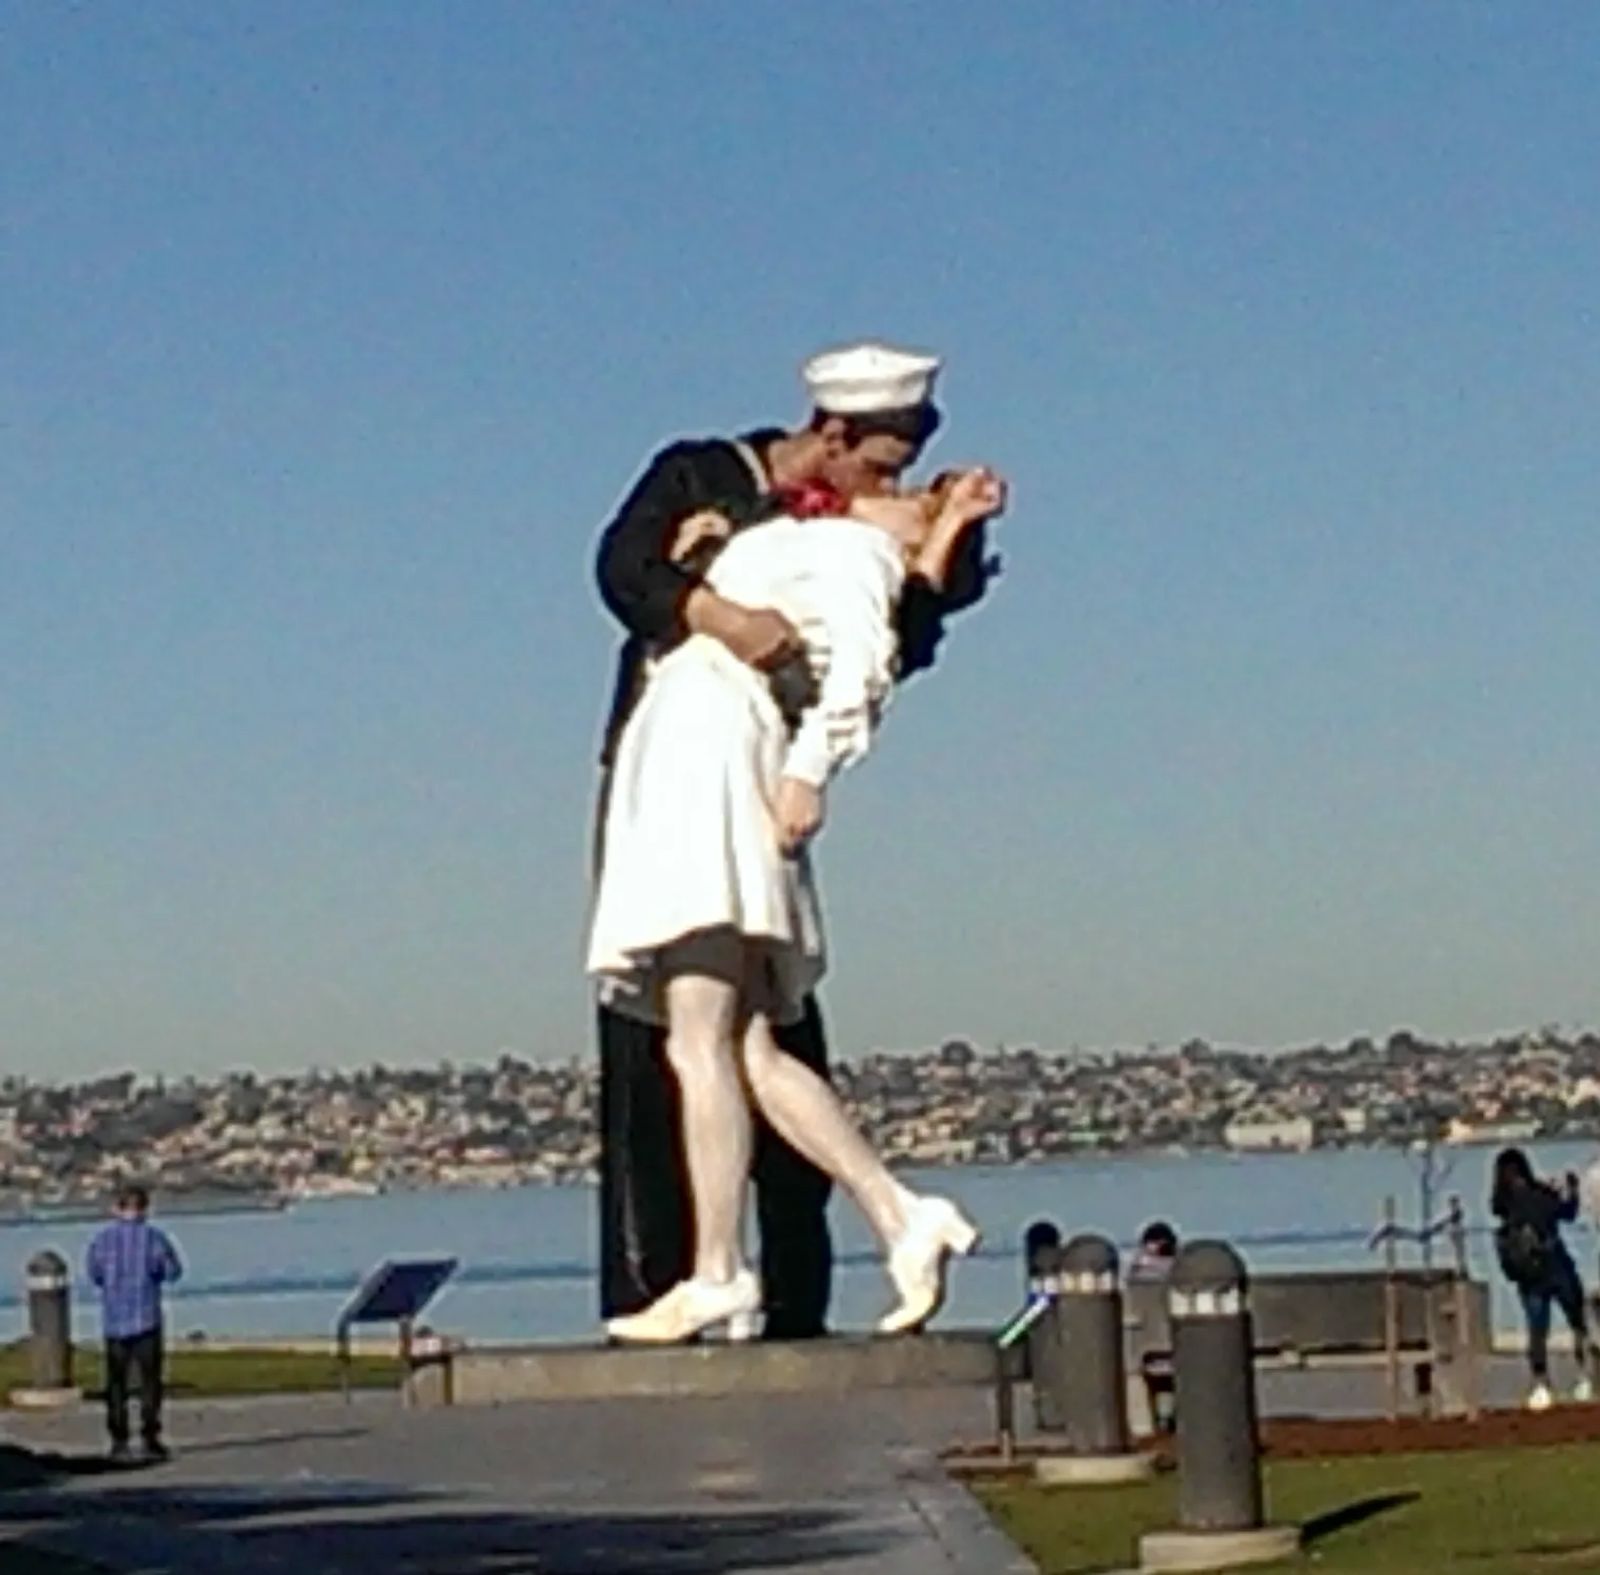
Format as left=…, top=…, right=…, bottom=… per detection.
left=595, top=337, right=994, bottom=1340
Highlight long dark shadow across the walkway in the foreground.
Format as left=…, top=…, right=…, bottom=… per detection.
left=6, top=1479, right=893, bottom=1575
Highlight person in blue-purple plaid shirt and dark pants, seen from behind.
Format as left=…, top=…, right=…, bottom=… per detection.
left=88, top=1186, right=184, bottom=1460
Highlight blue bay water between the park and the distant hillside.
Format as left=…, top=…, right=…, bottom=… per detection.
left=0, top=1143, right=1597, bottom=1341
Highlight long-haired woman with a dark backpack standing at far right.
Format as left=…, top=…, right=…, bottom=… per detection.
left=1490, top=1148, right=1594, bottom=1410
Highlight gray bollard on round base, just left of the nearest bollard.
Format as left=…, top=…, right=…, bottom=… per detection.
left=1037, top=1236, right=1155, bottom=1485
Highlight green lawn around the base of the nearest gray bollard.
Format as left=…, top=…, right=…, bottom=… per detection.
left=974, top=1444, right=1600, bottom=1575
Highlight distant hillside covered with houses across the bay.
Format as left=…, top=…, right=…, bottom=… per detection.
left=0, top=1028, right=1600, bottom=1218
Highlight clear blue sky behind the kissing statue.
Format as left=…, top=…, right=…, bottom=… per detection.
left=0, top=0, right=1600, bottom=1076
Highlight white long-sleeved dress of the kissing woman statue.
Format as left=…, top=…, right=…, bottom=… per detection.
left=587, top=519, right=904, bottom=1023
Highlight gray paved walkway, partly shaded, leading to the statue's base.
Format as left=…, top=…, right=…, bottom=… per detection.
left=0, top=1389, right=1032, bottom=1575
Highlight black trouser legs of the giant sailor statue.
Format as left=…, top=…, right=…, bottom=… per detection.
left=600, top=999, right=834, bottom=1340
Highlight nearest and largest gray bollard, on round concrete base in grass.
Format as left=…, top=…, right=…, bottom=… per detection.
left=1139, top=1242, right=1299, bottom=1570
